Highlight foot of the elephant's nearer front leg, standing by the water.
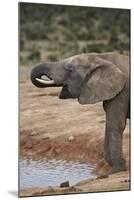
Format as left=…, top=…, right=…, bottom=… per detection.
left=111, top=159, right=127, bottom=173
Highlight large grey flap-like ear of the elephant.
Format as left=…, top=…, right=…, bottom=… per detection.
left=78, top=60, right=125, bottom=104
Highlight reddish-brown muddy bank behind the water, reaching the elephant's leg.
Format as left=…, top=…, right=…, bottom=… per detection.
left=20, top=126, right=129, bottom=174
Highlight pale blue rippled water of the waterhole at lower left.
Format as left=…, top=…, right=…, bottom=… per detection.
left=20, top=159, right=95, bottom=189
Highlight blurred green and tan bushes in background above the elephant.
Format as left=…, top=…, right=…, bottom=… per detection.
left=19, top=3, right=130, bottom=65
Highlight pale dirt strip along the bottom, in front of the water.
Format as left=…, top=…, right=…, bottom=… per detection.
left=19, top=172, right=130, bottom=197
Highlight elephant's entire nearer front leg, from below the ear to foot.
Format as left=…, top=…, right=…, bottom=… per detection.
left=104, top=98, right=127, bottom=173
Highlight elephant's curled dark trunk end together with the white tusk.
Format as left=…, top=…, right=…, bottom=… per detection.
left=31, top=63, right=55, bottom=88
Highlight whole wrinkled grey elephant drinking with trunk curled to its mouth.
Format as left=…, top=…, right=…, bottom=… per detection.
left=31, top=53, right=129, bottom=173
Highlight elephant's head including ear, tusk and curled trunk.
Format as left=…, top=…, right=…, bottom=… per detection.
left=31, top=54, right=125, bottom=104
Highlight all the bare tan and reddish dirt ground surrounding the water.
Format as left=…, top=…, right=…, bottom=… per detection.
left=20, top=67, right=130, bottom=196
